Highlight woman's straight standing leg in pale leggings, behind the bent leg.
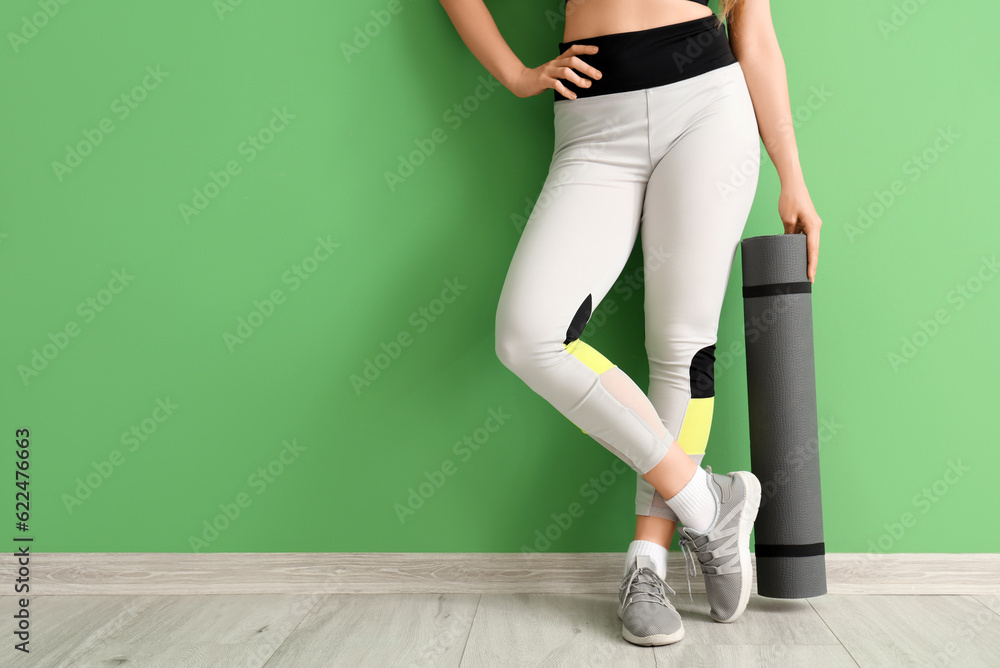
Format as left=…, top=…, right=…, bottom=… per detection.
left=636, top=63, right=760, bottom=547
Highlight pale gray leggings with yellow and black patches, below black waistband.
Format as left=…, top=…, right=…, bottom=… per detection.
left=496, top=62, right=760, bottom=521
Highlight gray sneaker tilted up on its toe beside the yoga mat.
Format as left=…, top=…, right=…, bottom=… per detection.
left=677, top=466, right=760, bottom=622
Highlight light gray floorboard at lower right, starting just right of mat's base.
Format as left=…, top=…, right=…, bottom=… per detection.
left=810, top=595, right=1000, bottom=668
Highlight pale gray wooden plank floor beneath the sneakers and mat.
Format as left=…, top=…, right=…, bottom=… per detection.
left=15, top=592, right=1000, bottom=668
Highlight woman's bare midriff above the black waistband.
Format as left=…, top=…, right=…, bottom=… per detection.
left=562, top=0, right=713, bottom=42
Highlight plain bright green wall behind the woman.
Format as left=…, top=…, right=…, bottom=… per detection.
left=0, top=0, right=1000, bottom=552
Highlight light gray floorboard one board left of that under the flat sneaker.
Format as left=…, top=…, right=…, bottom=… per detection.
left=265, top=594, right=480, bottom=668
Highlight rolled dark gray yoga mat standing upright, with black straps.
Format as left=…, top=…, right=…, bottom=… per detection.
left=740, top=234, right=826, bottom=598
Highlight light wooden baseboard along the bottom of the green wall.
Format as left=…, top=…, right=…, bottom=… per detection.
left=30, top=552, right=1000, bottom=596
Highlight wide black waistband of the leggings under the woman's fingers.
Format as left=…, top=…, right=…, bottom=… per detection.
left=552, top=14, right=736, bottom=101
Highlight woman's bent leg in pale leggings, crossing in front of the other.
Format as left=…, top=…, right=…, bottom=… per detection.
left=496, top=90, right=674, bottom=474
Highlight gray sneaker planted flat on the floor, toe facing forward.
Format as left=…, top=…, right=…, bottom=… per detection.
left=618, top=554, right=684, bottom=647
